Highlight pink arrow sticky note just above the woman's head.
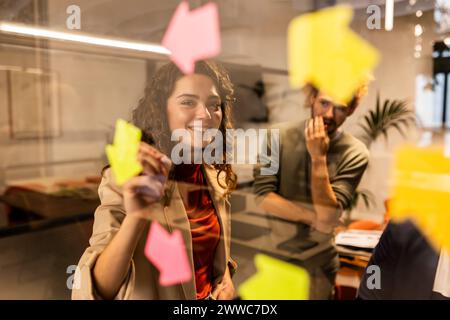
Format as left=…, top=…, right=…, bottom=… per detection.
left=162, top=1, right=220, bottom=74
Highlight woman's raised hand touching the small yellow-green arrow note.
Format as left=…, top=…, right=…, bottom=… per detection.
left=123, top=142, right=172, bottom=218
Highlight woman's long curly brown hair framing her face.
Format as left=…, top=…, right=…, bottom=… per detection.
left=132, top=61, right=237, bottom=194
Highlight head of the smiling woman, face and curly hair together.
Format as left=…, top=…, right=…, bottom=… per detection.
left=133, top=61, right=236, bottom=195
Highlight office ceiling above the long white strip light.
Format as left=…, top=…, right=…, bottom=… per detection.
left=0, top=0, right=434, bottom=42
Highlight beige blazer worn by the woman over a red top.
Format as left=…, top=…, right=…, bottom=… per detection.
left=72, top=165, right=236, bottom=299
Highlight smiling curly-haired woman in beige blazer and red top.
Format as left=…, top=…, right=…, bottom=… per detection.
left=72, top=62, right=236, bottom=299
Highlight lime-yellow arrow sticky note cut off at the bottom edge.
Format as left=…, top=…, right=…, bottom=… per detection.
left=239, top=254, right=309, bottom=300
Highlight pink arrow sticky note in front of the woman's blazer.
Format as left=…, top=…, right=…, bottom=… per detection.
left=144, top=221, right=192, bottom=286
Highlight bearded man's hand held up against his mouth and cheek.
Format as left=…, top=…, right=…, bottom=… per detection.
left=305, top=117, right=330, bottom=160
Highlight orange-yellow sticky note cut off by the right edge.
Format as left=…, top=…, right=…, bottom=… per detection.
left=389, top=146, right=450, bottom=250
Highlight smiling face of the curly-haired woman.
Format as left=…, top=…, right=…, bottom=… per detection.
left=167, top=74, right=223, bottom=147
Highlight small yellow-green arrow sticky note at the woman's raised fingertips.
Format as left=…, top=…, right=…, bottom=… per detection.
left=106, top=119, right=142, bottom=185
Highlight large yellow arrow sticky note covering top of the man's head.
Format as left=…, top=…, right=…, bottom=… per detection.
left=288, top=5, right=379, bottom=102
